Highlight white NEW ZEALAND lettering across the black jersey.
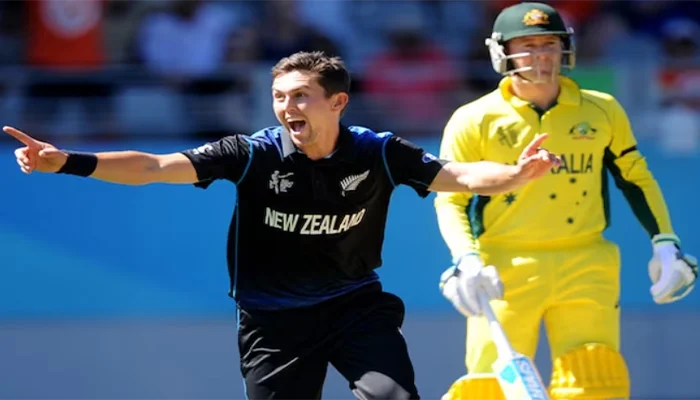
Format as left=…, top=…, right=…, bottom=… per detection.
left=265, top=207, right=365, bottom=235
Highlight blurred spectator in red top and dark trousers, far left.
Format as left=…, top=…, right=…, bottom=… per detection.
left=23, top=0, right=114, bottom=142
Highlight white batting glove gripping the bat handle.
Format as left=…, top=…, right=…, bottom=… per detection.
left=440, top=254, right=503, bottom=317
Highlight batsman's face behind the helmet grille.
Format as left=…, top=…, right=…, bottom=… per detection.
left=507, top=35, right=564, bottom=83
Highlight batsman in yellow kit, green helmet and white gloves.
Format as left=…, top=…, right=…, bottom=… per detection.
left=435, top=3, right=697, bottom=400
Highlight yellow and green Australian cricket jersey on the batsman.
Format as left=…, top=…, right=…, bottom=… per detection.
left=435, top=77, right=673, bottom=257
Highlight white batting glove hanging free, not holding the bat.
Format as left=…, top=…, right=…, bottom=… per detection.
left=649, top=234, right=698, bottom=304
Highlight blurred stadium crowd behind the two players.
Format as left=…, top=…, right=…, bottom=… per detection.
left=0, top=0, right=700, bottom=155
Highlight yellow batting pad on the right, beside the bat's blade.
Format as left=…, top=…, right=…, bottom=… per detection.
left=550, top=344, right=630, bottom=400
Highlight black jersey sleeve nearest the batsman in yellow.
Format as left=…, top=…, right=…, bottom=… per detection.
left=384, top=136, right=446, bottom=197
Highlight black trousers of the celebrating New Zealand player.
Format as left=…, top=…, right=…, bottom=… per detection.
left=238, top=283, right=419, bottom=400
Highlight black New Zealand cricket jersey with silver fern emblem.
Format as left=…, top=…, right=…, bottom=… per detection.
left=183, top=126, right=444, bottom=310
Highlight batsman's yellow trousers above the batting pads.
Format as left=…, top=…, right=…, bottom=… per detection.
left=466, top=238, right=620, bottom=372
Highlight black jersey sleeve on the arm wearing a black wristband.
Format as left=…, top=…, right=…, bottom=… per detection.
left=182, top=135, right=253, bottom=189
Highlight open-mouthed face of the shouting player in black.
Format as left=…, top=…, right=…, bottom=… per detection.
left=272, top=71, right=347, bottom=147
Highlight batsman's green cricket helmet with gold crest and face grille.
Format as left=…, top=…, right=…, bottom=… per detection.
left=486, top=3, right=576, bottom=83
